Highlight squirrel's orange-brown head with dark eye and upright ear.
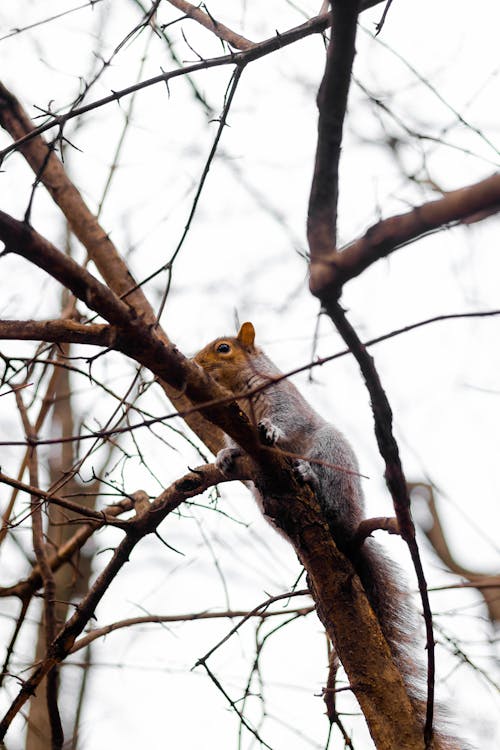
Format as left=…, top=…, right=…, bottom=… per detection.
left=193, top=323, right=258, bottom=393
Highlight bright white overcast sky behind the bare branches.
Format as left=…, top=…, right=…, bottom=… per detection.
left=0, top=0, right=500, bottom=750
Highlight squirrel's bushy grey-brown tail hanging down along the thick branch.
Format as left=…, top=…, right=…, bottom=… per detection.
left=353, top=539, right=467, bottom=750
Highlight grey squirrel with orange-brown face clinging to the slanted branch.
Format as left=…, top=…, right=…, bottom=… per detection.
left=194, top=322, right=464, bottom=750
